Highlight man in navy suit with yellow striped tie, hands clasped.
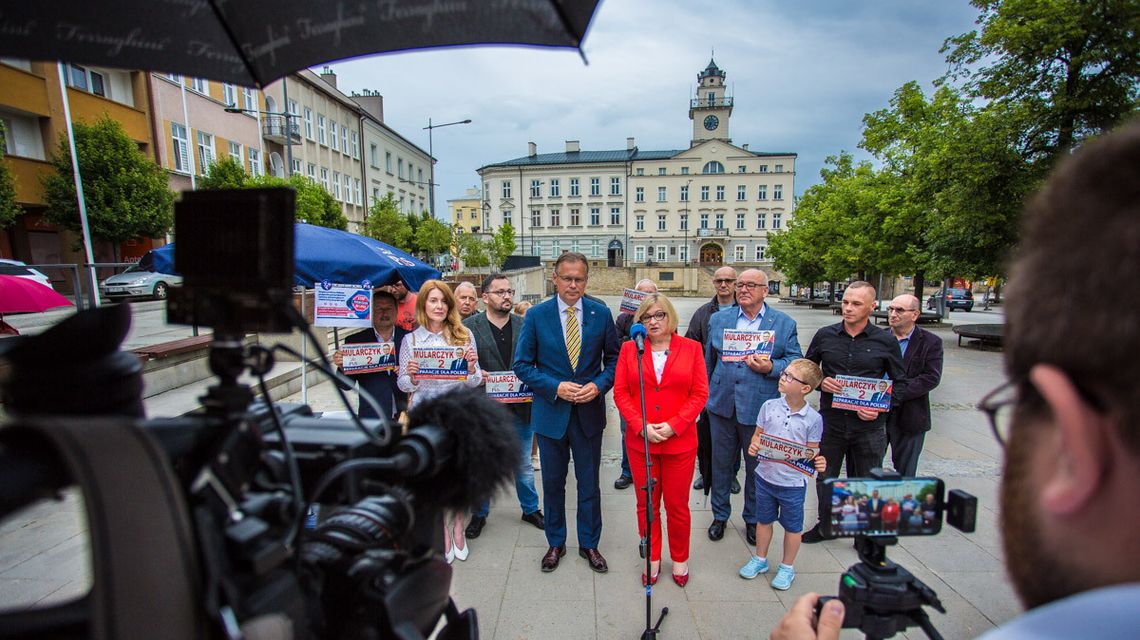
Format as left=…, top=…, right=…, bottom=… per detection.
left=513, top=252, right=619, bottom=573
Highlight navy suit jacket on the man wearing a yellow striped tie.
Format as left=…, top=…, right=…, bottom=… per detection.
left=512, top=294, right=618, bottom=439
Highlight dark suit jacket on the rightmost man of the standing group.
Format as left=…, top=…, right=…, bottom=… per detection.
left=887, top=326, right=942, bottom=434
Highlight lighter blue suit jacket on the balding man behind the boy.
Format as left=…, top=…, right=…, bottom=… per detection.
left=705, top=302, right=803, bottom=424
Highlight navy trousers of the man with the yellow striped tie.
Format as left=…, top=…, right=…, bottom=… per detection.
left=538, top=407, right=602, bottom=549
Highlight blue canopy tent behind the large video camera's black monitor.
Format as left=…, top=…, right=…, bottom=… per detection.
left=143, top=222, right=440, bottom=287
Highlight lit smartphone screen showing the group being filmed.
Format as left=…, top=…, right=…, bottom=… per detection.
left=823, top=478, right=945, bottom=537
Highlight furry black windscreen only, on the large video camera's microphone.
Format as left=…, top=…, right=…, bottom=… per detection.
left=408, top=388, right=517, bottom=510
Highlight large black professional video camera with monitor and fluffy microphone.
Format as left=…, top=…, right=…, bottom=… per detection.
left=0, top=189, right=520, bottom=640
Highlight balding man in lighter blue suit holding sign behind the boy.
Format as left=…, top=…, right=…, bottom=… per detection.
left=705, top=269, right=801, bottom=545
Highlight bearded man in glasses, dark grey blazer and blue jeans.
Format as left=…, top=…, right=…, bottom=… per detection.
left=463, top=274, right=546, bottom=538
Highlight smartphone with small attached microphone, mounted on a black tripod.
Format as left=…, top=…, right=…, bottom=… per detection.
left=815, top=469, right=978, bottom=640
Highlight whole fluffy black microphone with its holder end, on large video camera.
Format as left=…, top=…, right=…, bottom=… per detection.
left=394, top=388, right=522, bottom=510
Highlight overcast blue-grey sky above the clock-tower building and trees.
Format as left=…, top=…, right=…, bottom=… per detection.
left=328, top=0, right=977, bottom=218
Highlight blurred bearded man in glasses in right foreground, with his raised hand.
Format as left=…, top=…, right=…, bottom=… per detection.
left=772, top=122, right=1140, bottom=640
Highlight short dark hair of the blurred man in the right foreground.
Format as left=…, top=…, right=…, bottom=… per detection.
left=1004, top=120, right=1140, bottom=454
